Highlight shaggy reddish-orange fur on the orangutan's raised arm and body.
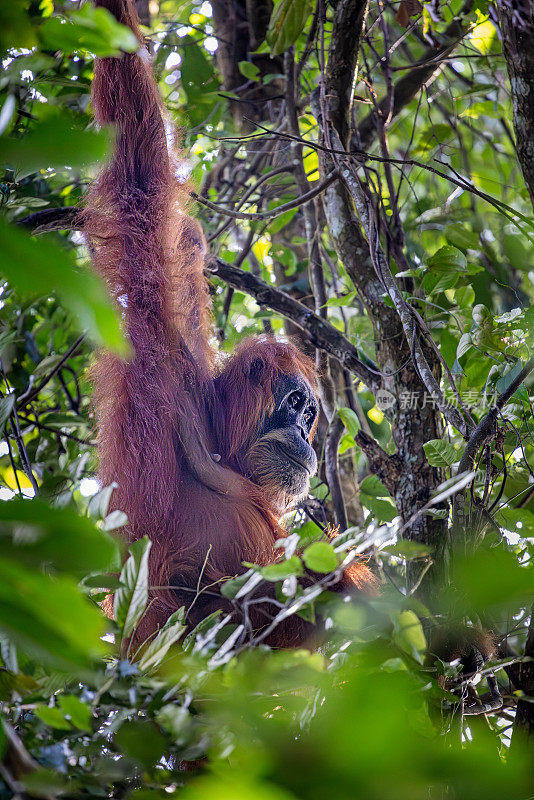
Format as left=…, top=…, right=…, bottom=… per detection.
left=84, top=0, right=373, bottom=645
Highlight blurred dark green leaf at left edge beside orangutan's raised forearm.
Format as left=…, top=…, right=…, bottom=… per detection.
left=0, top=106, right=109, bottom=180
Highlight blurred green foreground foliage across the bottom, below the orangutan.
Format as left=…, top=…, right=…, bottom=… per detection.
left=0, top=516, right=532, bottom=800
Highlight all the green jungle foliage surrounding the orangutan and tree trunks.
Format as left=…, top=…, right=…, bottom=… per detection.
left=0, top=0, right=534, bottom=800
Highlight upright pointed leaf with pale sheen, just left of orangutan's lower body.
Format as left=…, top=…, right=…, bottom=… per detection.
left=113, top=536, right=152, bottom=638
